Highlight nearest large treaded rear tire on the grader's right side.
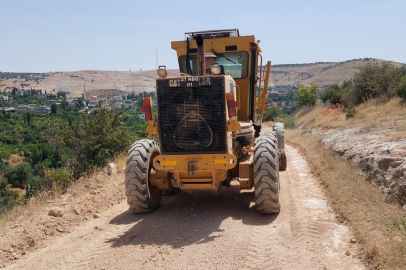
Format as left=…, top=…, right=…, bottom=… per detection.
left=254, top=132, right=280, bottom=214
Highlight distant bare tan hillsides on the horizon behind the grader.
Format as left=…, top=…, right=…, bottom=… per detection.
left=0, top=58, right=401, bottom=96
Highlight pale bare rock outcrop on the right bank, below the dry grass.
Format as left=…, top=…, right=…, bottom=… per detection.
left=320, top=128, right=406, bottom=205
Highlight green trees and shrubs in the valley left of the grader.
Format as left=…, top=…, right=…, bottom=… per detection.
left=0, top=90, right=152, bottom=215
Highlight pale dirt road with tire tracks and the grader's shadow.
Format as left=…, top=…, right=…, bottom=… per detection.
left=3, top=146, right=364, bottom=269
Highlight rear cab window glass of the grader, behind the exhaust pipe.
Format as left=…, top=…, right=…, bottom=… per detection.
left=179, top=52, right=248, bottom=79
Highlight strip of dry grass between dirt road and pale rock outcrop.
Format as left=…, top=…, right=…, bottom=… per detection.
left=287, top=130, right=406, bottom=269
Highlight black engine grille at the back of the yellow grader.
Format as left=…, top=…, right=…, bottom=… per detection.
left=157, top=78, right=227, bottom=154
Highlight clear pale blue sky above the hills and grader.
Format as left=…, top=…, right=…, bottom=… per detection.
left=0, top=0, right=406, bottom=72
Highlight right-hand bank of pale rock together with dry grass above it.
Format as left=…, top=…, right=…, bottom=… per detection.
left=297, top=98, right=406, bottom=208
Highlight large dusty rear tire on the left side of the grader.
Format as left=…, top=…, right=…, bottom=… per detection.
left=125, top=140, right=162, bottom=213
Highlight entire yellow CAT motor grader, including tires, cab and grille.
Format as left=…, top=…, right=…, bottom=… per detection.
left=125, top=29, right=286, bottom=214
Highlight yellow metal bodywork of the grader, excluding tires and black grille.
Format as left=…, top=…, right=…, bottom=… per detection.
left=147, top=29, right=270, bottom=191
